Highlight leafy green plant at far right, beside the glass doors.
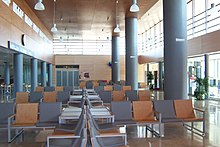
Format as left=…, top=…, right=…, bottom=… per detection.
left=194, top=77, right=209, bottom=100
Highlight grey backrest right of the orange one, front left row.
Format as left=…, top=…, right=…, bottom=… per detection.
left=39, top=102, right=62, bottom=122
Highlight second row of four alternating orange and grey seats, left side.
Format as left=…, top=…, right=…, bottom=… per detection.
left=15, top=91, right=70, bottom=104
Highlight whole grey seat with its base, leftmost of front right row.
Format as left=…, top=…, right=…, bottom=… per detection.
left=111, top=101, right=136, bottom=125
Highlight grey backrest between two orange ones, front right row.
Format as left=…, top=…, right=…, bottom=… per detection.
left=153, top=100, right=176, bottom=119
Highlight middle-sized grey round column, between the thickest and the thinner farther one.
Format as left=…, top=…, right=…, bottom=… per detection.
left=125, top=17, right=138, bottom=90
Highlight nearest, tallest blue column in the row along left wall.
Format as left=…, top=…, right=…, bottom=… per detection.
left=14, top=53, right=23, bottom=96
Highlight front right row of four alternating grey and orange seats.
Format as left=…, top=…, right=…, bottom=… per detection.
left=111, top=100, right=205, bottom=136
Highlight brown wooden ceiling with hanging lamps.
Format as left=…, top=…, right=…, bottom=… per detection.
left=25, top=0, right=158, bottom=40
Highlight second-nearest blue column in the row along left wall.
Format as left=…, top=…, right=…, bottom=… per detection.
left=31, top=58, right=38, bottom=92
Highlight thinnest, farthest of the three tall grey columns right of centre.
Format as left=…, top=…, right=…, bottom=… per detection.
left=112, top=33, right=120, bottom=82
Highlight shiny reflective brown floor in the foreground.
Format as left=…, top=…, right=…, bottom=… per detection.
left=0, top=93, right=220, bottom=147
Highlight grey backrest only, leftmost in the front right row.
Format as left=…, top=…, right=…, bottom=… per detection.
left=111, top=101, right=132, bottom=121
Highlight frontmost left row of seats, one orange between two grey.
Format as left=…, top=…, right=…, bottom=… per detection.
left=0, top=102, right=62, bottom=142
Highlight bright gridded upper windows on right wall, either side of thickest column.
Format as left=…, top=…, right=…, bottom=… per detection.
left=139, top=0, right=220, bottom=55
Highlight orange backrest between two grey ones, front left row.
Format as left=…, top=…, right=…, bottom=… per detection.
left=15, top=103, right=38, bottom=124
